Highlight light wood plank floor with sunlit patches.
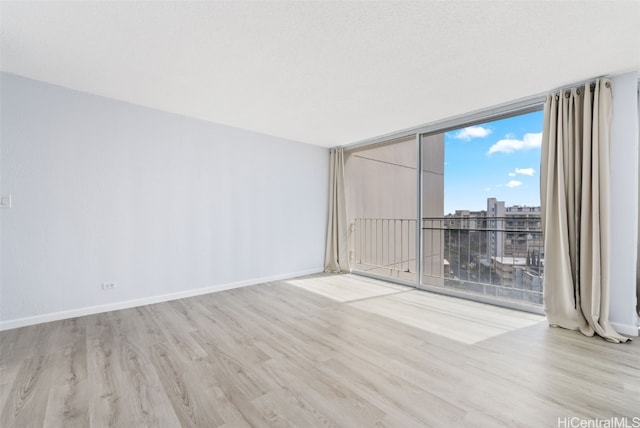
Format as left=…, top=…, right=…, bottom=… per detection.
left=0, top=276, right=640, bottom=428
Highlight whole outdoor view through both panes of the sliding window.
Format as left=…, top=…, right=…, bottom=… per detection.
left=346, top=111, right=544, bottom=305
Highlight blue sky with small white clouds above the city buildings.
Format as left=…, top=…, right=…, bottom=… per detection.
left=444, top=111, right=543, bottom=214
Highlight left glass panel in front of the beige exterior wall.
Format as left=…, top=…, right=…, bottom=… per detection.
left=345, top=137, right=418, bottom=283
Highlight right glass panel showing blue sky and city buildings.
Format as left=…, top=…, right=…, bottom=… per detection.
left=422, top=111, right=544, bottom=305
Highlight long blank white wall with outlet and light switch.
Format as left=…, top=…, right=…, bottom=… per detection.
left=0, top=73, right=328, bottom=329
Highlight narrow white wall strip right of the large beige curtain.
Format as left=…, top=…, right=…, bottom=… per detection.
left=609, top=72, right=638, bottom=335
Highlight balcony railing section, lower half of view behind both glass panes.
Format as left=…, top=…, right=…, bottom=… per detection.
left=351, top=215, right=544, bottom=306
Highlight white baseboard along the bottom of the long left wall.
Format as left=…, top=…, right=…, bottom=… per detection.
left=0, top=268, right=324, bottom=331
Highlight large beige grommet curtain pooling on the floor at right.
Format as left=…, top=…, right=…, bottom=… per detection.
left=540, top=79, right=627, bottom=342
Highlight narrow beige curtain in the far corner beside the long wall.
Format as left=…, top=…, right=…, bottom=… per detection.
left=324, top=147, right=350, bottom=272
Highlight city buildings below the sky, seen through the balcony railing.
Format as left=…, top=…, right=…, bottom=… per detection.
left=436, top=198, right=544, bottom=304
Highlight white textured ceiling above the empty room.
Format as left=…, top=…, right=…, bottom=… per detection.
left=0, top=0, right=640, bottom=147
